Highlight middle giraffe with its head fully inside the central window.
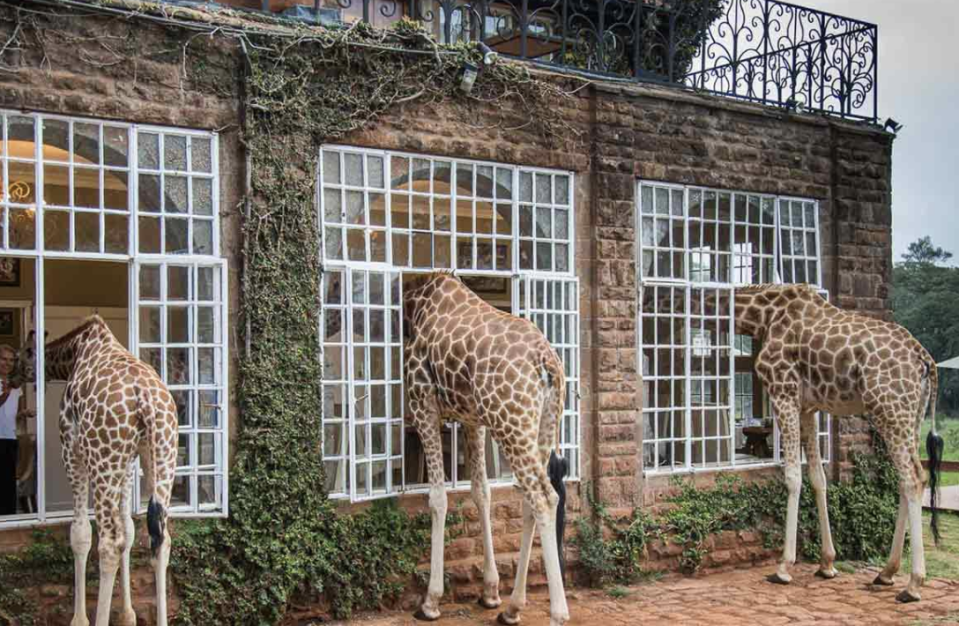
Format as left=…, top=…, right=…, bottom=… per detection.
left=403, top=272, right=569, bottom=626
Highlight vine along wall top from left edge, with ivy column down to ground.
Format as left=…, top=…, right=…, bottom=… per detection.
left=0, top=0, right=585, bottom=624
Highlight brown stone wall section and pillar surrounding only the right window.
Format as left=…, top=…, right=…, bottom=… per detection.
left=584, top=84, right=892, bottom=490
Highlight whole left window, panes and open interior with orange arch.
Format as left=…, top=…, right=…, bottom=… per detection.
left=0, top=111, right=228, bottom=527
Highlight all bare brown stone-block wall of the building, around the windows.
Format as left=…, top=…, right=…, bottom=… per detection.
left=0, top=0, right=891, bottom=608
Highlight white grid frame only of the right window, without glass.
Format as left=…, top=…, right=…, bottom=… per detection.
left=635, top=180, right=832, bottom=475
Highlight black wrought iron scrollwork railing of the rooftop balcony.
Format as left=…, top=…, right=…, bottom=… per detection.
left=276, top=0, right=878, bottom=122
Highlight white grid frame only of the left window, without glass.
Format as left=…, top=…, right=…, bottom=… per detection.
left=0, top=109, right=229, bottom=530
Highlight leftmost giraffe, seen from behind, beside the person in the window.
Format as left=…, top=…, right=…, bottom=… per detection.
left=20, top=315, right=177, bottom=626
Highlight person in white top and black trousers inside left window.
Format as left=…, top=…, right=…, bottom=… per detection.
left=0, top=344, right=30, bottom=515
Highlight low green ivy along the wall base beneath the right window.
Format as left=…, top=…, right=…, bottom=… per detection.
left=574, top=431, right=899, bottom=586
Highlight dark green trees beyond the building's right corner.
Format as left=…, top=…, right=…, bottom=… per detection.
left=892, top=236, right=959, bottom=414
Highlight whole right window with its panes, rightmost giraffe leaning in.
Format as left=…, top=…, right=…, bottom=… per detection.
left=637, top=183, right=830, bottom=472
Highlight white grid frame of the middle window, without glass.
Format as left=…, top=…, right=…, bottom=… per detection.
left=316, top=144, right=581, bottom=502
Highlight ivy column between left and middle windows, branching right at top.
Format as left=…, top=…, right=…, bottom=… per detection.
left=174, top=13, right=576, bottom=624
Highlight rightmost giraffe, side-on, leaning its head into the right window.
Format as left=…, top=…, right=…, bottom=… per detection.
left=734, top=284, right=942, bottom=602
